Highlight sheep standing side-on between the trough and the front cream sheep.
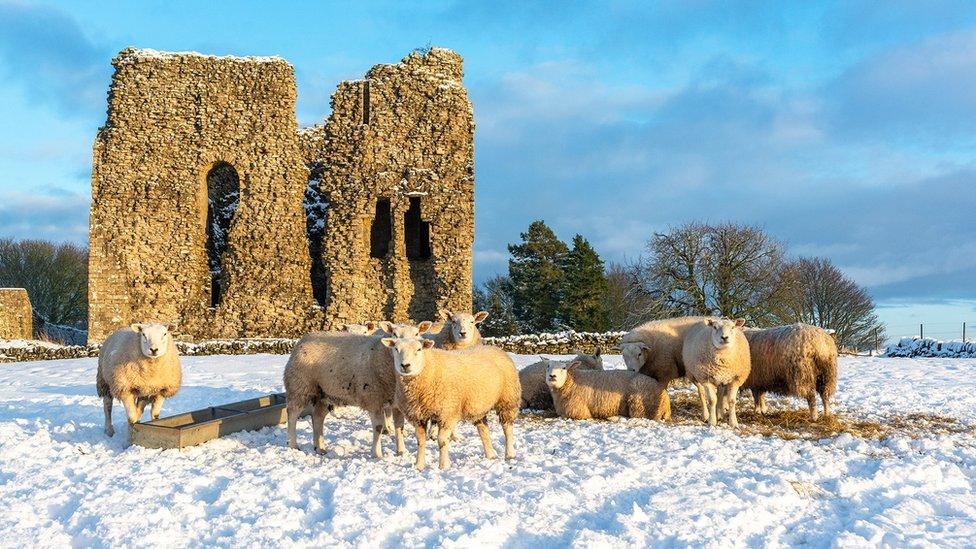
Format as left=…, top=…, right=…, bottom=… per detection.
left=284, top=330, right=417, bottom=459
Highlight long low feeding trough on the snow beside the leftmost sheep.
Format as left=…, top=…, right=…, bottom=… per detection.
left=131, top=393, right=296, bottom=448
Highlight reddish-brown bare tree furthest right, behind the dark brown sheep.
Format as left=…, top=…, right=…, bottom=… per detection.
left=777, top=257, right=885, bottom=350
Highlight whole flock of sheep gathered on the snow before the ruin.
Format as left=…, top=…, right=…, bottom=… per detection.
left=96, top=312, right=837, bottom=469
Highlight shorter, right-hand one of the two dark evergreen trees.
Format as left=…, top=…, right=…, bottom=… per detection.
left=561, top=235, right=608, bottom=332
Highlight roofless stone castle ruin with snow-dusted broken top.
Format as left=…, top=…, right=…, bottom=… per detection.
left=88, top=48, right=474, bottom=342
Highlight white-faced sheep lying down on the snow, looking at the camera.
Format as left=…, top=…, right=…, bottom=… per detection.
left=546, top=360, right=671, bottom=421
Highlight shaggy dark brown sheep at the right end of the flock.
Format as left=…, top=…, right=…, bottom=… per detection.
left=741, top=323, right=837, bottom=421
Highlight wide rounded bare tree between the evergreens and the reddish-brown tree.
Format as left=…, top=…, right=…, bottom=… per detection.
left=638, top=223, right=788, bottom=326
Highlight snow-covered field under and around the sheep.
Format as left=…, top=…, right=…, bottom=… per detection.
left=0, top=355, right=976, bottom=548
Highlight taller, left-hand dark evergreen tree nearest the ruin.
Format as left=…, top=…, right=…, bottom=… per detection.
left=508, top=220, right=569, bottom=333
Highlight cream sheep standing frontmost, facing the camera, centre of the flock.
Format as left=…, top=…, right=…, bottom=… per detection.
left=383, top=337, right=522, bottom=470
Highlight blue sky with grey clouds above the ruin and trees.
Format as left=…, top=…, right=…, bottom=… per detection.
left=0, top=0, right=976, bottom=338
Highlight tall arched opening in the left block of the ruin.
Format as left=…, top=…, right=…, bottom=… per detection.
left=207, top=162, right=241, bottom=307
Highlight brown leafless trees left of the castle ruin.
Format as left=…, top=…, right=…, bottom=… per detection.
left=0, top=235, right=88, bottom=329
